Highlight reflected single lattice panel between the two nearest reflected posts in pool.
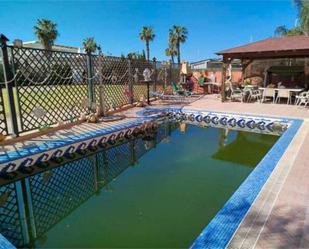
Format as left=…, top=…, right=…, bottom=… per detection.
left=29, top=158, right=95, bottom=236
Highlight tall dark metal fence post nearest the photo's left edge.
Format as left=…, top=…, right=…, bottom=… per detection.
left=0, top=34, right=18, bottom=136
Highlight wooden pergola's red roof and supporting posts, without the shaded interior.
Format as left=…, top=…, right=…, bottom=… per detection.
left=216, top=36, right=309, bottom=101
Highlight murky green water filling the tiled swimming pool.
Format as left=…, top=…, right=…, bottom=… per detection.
left=0, top=123, right=278, bottom=248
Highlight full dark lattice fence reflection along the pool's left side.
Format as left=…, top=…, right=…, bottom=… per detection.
left=0, top=121, right=171, bottom=246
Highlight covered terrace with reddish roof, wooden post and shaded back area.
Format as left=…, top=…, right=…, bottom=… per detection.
left=217, top=36, right=309, bottom=101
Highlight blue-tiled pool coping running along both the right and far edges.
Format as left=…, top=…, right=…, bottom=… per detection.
left=0, top=107, right=303, bottom=249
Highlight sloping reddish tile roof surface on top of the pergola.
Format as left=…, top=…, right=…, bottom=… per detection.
left=216, top=36, right=309, bottom=55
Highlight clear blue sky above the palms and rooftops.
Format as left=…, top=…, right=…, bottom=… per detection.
left=0, top=0, right=297, bottom=61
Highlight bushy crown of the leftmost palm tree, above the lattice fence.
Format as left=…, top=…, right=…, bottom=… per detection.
left=33, top=19, right=59, bottom=50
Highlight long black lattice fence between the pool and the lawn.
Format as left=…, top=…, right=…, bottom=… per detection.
left=0, top=35, right=179, bottom=135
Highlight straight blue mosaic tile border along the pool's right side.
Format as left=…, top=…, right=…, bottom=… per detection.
left=191, top=119, right=303, bottom=249
